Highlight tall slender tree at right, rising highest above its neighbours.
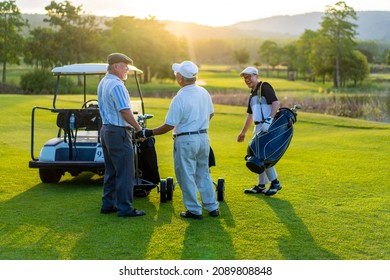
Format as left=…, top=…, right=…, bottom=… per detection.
left=320, top=1, right=357, bottom=88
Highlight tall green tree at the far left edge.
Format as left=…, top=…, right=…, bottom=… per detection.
left=0, top=0, right=28, bottom=83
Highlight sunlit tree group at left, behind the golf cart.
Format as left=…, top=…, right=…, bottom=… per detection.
left=0, top=0, right=187, bottom=86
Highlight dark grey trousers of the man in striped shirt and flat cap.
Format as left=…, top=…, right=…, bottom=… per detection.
left=101, top=125, right=134, bottom=214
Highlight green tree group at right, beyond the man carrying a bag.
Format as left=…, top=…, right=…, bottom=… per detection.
left=234, top=1, right=390, bottom=88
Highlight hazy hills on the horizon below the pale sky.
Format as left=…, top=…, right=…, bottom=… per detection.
left=165, top=11, right=390, bottom=42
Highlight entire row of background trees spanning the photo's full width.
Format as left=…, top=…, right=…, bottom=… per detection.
left=0, top=0, right=390, bottom=88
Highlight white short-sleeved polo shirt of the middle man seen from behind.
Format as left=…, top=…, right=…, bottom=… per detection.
left=165, top=84, right=214, bottom=134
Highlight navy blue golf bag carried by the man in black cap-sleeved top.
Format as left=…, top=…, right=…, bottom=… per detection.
left=245, top=108, right=297, bottom=174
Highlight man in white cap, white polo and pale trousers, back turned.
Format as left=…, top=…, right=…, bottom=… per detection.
left=137, top=61, right=219, bottom=219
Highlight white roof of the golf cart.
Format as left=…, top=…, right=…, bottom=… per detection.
left=51, top=63, right=143, bottom=75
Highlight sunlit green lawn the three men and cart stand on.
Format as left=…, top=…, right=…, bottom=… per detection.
left=0, top=95, right=390, bottom=260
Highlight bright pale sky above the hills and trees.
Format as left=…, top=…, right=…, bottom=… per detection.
left=16, top=0, right=390, bottom=26
